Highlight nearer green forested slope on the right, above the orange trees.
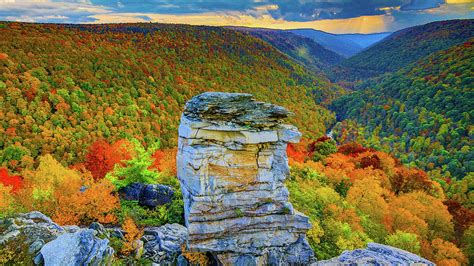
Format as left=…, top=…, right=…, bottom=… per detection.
left=333, top=39, right=474, bottom=179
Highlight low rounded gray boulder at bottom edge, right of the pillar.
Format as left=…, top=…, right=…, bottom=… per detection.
left=312, top=243, right=435, bottom=266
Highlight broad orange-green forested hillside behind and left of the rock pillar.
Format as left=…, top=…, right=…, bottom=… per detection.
left=0, top=23, right=340, bottom=170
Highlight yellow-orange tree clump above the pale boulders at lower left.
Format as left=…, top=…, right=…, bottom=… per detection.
left=16, top=155, right=120, bottom=225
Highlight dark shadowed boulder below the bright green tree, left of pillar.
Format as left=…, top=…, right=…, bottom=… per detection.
left=138, top=184, right=174, bottom=208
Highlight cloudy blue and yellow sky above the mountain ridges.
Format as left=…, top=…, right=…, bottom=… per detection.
left=0, top=0, right=474, bottom=33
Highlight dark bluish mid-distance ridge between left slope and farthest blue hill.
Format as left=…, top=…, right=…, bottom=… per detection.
left=233, top=27, right=344, bottom=71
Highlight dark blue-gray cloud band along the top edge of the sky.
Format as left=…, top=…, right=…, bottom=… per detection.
left=87, top=0, right=454, bottom=21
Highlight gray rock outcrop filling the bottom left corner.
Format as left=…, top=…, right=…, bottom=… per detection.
left=0, top=211, right=114, bottom=265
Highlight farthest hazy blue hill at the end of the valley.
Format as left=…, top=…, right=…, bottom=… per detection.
left=289, top=29, right=390, bottom=57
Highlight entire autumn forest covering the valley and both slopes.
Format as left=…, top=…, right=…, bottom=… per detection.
left=0, top=20, right=474, bottom=265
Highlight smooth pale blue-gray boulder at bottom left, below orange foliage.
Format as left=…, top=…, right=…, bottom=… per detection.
left=40, top=229, right=114, bottom=265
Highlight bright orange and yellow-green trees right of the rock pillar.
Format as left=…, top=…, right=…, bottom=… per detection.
left=287, top=140, right=474, bottom=265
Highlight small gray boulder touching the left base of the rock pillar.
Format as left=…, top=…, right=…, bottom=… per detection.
left=142, top=224, right=188, bottom=265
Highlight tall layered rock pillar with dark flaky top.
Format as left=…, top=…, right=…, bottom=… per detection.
left=177, top=92, right=313, bottom=264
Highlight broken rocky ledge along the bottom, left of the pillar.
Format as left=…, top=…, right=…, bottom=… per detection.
left=0, top=211, right=187, bottom=265
